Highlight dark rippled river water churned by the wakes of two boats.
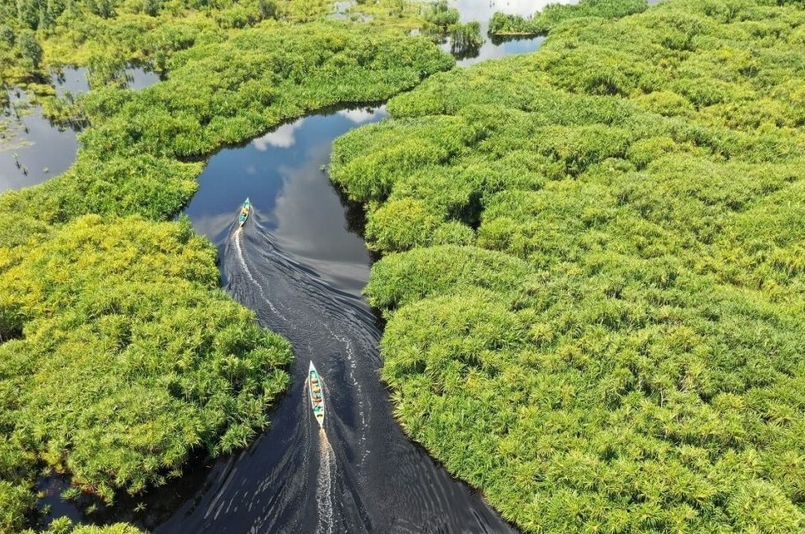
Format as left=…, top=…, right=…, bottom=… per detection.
left=155, top=211, right=512, bottom=534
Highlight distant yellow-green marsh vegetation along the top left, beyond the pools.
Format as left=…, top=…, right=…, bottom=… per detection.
left=0, top=0, right=434, bottom=87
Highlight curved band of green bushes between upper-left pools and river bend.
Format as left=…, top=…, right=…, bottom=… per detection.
left=0, top=22, right=453, bottom=228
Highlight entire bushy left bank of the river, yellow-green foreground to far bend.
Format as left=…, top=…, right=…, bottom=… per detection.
left=0, top=4, right=453, bottom=532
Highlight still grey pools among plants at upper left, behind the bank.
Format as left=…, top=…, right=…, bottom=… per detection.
left=0, top=67, right=159, bottom=193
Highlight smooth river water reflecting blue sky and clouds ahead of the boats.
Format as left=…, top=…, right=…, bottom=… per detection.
left=186, top=108, right=386, bottom=294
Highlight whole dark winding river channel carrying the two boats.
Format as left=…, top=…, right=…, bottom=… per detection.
left=23, top=0, right=564, bottom=534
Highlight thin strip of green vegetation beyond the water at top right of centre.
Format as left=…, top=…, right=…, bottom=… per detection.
left=489, top=0, right=648, bottom=35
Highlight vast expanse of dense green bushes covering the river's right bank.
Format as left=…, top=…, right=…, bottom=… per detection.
left=331, top=0, right=805, bottom=534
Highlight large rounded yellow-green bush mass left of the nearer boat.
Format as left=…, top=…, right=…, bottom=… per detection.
left=0, top=215, right=291, bottom=516
